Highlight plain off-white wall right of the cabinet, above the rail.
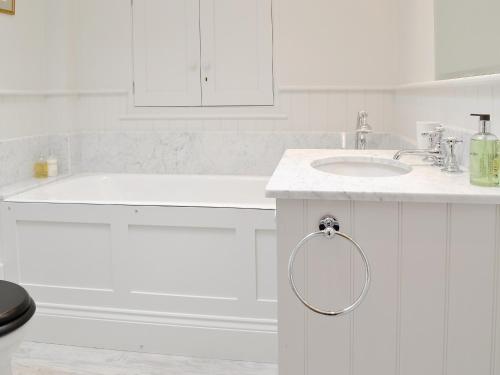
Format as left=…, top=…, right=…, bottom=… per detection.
left=254, top=0, right=398, bottom=86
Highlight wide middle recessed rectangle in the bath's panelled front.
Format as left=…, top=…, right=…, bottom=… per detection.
left=128, top=226, right=238, bottom=300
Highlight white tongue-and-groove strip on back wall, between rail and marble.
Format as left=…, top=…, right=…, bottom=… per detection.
left=72, top=87, right=396, bottom=137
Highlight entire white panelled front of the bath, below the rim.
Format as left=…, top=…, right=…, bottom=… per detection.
left=1, top=202, right=277, bottom=361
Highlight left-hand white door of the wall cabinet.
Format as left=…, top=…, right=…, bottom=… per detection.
left=133, top=0, right=201, bottom=106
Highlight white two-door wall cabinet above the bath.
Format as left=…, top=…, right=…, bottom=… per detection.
left=132, top=0, right=274, bottom=106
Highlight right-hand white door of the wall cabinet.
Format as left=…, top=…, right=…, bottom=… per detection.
left=200, top=0, right=274, bottom=106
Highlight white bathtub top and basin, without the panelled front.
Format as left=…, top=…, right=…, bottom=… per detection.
left=7, top=174, right=275, bottom=209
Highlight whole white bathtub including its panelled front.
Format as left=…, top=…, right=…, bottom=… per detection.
left=2, top=174, right=277, bottom=362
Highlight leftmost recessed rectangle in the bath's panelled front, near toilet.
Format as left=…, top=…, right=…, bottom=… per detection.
left=17, top=221, right=113, bottom=290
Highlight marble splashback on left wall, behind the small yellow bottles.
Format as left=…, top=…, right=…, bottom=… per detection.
left=0, top=134, right=70, bottom=186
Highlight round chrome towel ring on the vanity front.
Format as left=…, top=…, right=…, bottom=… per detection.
left=288, top=215, right=371, bottom=316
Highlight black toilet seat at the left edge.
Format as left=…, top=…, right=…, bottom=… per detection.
left=0, top=280, right=36, bottom=337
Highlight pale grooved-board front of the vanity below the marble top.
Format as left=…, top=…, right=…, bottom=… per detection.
left=277, top=200, right=500, bottom=375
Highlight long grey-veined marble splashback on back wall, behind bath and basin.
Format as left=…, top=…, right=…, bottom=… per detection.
left=71, top=131, right=410, bottom=175
